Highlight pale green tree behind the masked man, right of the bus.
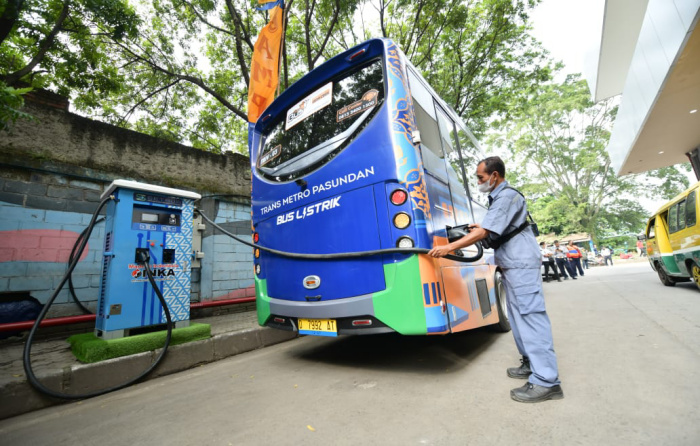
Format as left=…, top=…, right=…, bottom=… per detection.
left=492, top=75, right=688, bottom=240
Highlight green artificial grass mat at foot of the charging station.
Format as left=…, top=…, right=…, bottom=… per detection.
left=67, top=324, right=211, bottom=363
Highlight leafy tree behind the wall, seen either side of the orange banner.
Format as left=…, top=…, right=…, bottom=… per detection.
left=80, top=0, right=356, bottom=152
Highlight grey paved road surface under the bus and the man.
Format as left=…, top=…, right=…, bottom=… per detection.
left=0, top=263, right=700, bottom=446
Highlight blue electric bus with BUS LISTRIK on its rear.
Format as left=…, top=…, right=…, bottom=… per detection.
left=250, top=39, right=510, bottom=336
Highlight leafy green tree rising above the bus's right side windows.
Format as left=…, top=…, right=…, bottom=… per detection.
left=379, top=0, right=553, bottom=136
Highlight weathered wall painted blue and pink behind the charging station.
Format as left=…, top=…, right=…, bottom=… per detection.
left=0, top=102, right=254, bottom=316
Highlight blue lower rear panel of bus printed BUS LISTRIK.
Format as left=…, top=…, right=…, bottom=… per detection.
left=256, top=183, right=385, bottom=301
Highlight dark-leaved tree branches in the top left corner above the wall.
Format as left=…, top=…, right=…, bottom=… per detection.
left=0, top=0, right=139, bottom=98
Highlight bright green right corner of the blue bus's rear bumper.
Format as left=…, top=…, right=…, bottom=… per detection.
left=372, top=255, right=428, bottom=335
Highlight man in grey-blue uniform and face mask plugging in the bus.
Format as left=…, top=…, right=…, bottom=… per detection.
left=429, top=156, right=564, bottom=403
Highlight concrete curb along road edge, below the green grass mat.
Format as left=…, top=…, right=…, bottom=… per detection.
left=0, top=327, right=297, bottom=420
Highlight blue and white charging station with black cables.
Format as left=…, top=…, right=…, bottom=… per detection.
left=95, top=180, right=201, bottom=339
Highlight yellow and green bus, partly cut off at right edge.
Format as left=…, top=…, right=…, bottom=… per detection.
left=646, top=182, right=700, bottom=288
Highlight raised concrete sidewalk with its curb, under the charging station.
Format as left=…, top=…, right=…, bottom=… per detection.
left=0, top=307, right=296, bottom=420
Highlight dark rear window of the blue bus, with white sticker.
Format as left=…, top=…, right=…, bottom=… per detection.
left=257, top=60, right=384, bottom=181
